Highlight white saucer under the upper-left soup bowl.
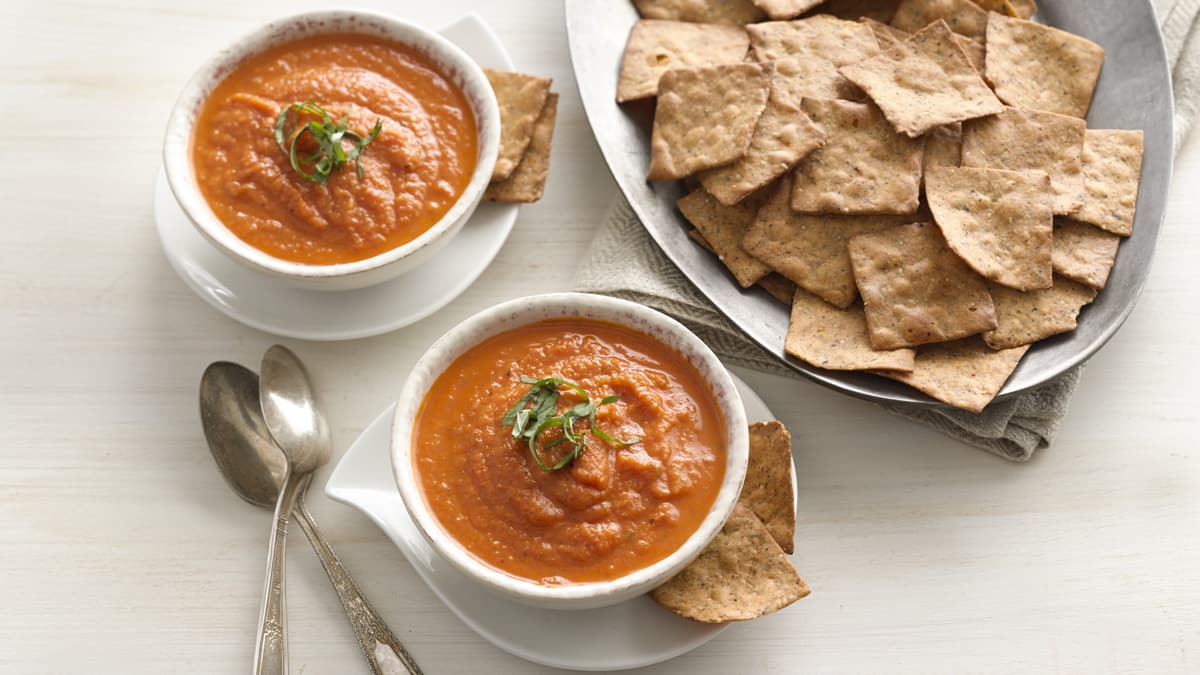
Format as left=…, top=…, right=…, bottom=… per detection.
left=155, top=14, right=518, bottom=340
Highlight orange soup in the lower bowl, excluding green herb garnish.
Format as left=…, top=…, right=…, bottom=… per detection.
left=413, top=318, right=726, bottom=585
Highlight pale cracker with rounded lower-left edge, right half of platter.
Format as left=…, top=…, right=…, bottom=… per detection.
left=925, top=167, right=1054, bottom=291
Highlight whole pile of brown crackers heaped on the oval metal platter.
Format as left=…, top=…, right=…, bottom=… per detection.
left=617, top=0, right=1142, bottom=412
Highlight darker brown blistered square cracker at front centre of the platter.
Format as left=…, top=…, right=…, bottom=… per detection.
left=848, top=222, right=996, bottom=350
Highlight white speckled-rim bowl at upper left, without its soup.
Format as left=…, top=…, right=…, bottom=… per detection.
left=163, top=10, right=500, bottom=291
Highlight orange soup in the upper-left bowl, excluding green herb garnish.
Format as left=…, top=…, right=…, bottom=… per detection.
left=191, top=34, right=476, bottom=264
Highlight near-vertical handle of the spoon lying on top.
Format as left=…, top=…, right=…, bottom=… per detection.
left=254, top=471, right=312, bottom=675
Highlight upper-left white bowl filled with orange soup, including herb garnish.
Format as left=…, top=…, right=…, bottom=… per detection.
left=163, top=11, right=500, bottom=289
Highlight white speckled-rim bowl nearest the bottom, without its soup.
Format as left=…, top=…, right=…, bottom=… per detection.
left=391, top=293, right=750, bottom=609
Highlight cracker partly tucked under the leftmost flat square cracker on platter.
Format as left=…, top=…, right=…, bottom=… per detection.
left=698, top=97, right=824, bottom=205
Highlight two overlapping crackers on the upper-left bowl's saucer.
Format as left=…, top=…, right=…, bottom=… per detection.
left=484, top=68, right=558, bottom=203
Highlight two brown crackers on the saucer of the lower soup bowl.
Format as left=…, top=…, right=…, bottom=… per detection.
left=650, top=422, right=810, bottom=623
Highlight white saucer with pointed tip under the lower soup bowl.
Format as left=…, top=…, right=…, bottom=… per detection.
left=325, top=375, right=796, bottom=670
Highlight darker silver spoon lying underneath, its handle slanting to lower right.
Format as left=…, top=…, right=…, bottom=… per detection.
left=200, top=362, right=421, bottom=675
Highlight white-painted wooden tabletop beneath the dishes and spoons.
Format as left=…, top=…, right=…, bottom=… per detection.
left=0, top=0, right=1200, bottom=675
